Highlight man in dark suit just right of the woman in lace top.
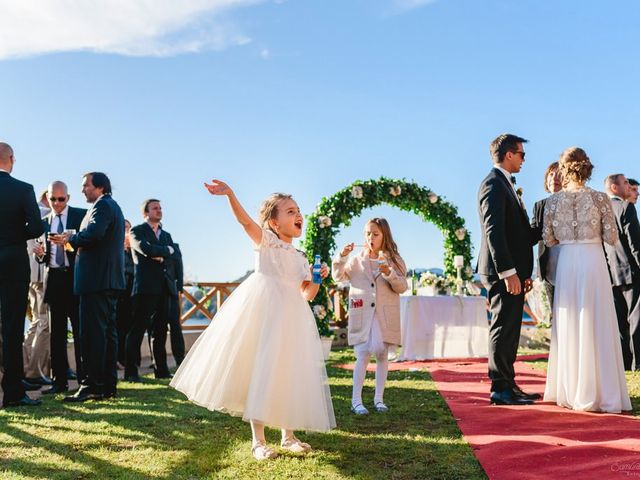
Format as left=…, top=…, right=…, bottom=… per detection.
left=604, top=173, right=640, bottom=370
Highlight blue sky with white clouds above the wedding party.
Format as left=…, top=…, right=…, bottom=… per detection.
left=0, top=0, right=640, bottom=281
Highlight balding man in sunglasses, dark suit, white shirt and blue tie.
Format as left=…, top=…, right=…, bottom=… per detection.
left=38, top=181, right=87, bottom=394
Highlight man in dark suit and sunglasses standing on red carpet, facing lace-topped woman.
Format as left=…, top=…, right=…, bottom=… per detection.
left=477, top=134, right=540, bottom=405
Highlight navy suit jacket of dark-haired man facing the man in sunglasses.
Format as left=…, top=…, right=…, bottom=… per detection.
left=69, top=195, right=126, bottom=295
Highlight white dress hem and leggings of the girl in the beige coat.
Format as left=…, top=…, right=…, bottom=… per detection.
left=351, top=316, right=389, bottom=407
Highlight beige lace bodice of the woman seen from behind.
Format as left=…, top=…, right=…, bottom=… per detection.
left=542, top=187, right=618, bottom=247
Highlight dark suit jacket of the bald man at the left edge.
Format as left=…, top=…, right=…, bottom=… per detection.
left=0, top=172, right=44, bottom=282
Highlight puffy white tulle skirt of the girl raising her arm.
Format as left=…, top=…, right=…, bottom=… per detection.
left=171, top=273, right=336, bottom=432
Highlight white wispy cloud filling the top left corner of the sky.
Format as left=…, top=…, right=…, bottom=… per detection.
left=0, top=0, right=265, bottom=59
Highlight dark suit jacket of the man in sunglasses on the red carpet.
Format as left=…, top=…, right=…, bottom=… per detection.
left=476, top=168, right=535, bottom=280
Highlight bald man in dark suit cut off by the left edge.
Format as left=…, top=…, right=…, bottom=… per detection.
left=0, top=142, right=43, bottom=407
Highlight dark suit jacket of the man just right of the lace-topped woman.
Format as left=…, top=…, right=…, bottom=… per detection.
left=604, top=197, right=640, bottom=287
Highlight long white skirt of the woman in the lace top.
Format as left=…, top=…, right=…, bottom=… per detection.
left=544, top=243, right=631, bottom=413
